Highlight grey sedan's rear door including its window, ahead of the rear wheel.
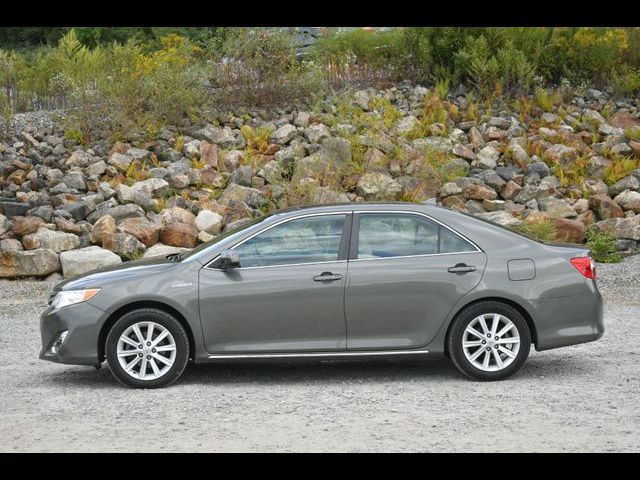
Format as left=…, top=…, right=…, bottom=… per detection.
left=345, top=212, right=486, bottom=350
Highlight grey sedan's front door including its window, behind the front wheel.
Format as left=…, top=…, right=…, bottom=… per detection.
left=199, top=213, right=351, bottom=353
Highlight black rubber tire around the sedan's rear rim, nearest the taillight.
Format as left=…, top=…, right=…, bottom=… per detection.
left=447, top=300, right=531, bottom=381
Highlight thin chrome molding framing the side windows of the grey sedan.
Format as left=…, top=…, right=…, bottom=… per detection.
left=204, top=210, right=483, bottom=271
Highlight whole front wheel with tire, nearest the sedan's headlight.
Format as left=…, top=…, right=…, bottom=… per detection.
left=105, top=308, right=189, bottom=388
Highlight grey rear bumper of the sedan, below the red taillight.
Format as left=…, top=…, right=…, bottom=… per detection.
left=531, top=280, right=604, bottom=350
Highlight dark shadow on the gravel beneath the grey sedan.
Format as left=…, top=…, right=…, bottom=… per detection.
left=37, top=356, right=597, bottom=389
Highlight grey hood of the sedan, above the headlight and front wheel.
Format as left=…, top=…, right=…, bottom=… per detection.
left=54, top=257, right=178, bottom=292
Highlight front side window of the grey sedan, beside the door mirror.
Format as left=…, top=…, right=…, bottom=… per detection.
left=233, top=215, right=345, bottom=268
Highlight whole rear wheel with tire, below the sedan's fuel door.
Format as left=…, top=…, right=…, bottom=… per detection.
left=448, top=301, right=531, bottom=380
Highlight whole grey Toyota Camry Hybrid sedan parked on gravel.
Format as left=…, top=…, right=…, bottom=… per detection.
left=40, top=203, right=604, bottom=388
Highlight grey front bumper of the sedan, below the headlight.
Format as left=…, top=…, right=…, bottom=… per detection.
left=40, top=302, right=107, bottom=366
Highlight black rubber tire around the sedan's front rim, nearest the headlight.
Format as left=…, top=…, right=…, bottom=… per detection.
left=105, top=308, right=189, bottom=388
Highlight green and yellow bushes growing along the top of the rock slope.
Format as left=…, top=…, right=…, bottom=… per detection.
left=0, top=27, right=640, bottom=137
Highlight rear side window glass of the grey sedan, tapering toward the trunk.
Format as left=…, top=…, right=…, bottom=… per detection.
left=358, top=213, right=476, bottom=258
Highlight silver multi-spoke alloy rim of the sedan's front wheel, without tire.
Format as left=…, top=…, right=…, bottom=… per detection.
left=117, top=322, right=176, bottom=380
